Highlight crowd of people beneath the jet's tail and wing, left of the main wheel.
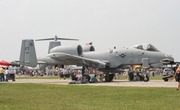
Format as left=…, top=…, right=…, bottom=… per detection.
left=16, top=67, right=104, bottom=83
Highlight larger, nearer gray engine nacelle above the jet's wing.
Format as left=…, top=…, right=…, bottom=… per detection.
left=50, top=45, right=83, bottom=56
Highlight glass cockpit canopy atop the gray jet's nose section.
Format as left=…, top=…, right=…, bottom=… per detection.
left=132, top=44, right=159, bottom=52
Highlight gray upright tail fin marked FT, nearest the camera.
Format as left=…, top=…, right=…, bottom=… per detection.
left=19, top=39, right=37, bottom=67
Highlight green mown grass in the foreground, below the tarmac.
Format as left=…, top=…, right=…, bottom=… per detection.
left=0, top=83, right=180, bottom=110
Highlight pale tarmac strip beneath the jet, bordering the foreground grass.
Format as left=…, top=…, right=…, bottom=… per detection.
left=8, top=79, right=178, bottom=88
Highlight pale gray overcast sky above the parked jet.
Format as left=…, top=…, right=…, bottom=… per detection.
left=0, top=0, right=180, bottom=61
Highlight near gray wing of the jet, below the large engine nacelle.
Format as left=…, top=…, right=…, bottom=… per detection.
left=47, top=53, right=108, bottom=68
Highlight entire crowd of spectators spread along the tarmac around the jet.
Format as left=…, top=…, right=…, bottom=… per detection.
left=0, top=64, right=180, bottom=90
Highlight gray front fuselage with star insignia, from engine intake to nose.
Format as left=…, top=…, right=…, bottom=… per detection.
left=83, top=48, right=174, bottom=68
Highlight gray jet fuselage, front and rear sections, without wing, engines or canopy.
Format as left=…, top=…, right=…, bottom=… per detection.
left=38, top=48, right=174, bottom=68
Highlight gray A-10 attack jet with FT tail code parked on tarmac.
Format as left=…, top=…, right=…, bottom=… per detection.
left=19, top=39, right=174, bottom=81
